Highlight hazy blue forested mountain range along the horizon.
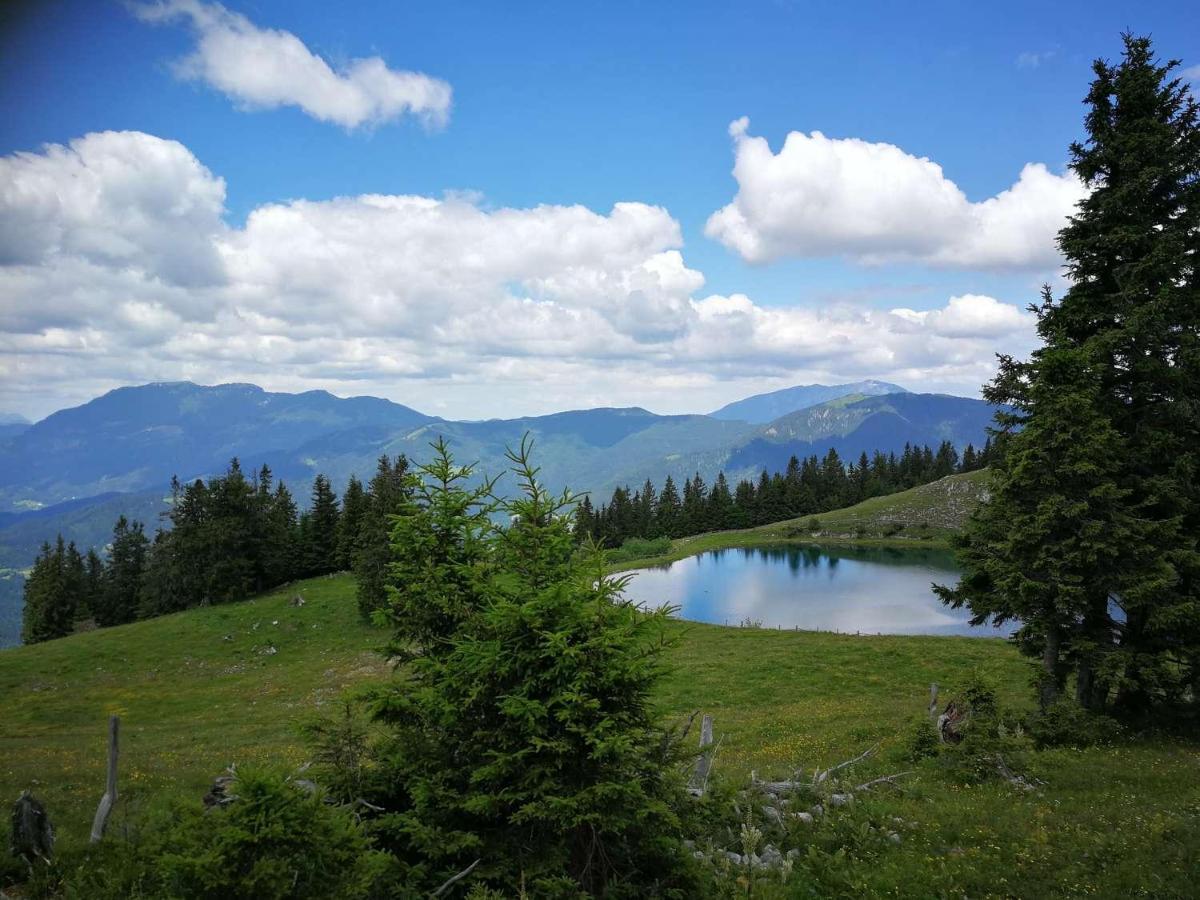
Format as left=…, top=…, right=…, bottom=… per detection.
left=0, top=380, right=992, bottom=646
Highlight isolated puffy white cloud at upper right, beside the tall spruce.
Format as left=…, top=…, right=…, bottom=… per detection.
left=704, top=118, right=1085, bottom=269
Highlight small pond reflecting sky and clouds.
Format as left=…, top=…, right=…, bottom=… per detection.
left=625, top=546, right=1013, bottom=637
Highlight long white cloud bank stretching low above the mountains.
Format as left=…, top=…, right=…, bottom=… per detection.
left=0, top=133, right=1032, bottom=415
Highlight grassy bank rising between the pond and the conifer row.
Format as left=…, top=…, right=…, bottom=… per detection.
left=604, top=470, right=988, bottom=570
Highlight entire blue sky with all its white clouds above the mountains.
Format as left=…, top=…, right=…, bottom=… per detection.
left=0, top=0, right=1200, bottom=419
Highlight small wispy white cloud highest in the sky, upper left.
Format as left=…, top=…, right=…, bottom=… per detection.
left=132, top=0, right=451, bottom=128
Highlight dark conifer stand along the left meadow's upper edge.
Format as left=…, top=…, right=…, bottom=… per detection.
left=22, top=456, right=412, bottom=643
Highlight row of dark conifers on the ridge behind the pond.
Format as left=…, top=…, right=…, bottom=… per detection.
left=575, top=438, right=997, bottom=547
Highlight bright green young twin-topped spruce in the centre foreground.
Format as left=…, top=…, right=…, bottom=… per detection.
left=362, top=443, right=683, bottom=895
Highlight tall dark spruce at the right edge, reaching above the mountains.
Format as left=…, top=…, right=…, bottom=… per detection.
left=940, top=35, right=1200, bottom=713
